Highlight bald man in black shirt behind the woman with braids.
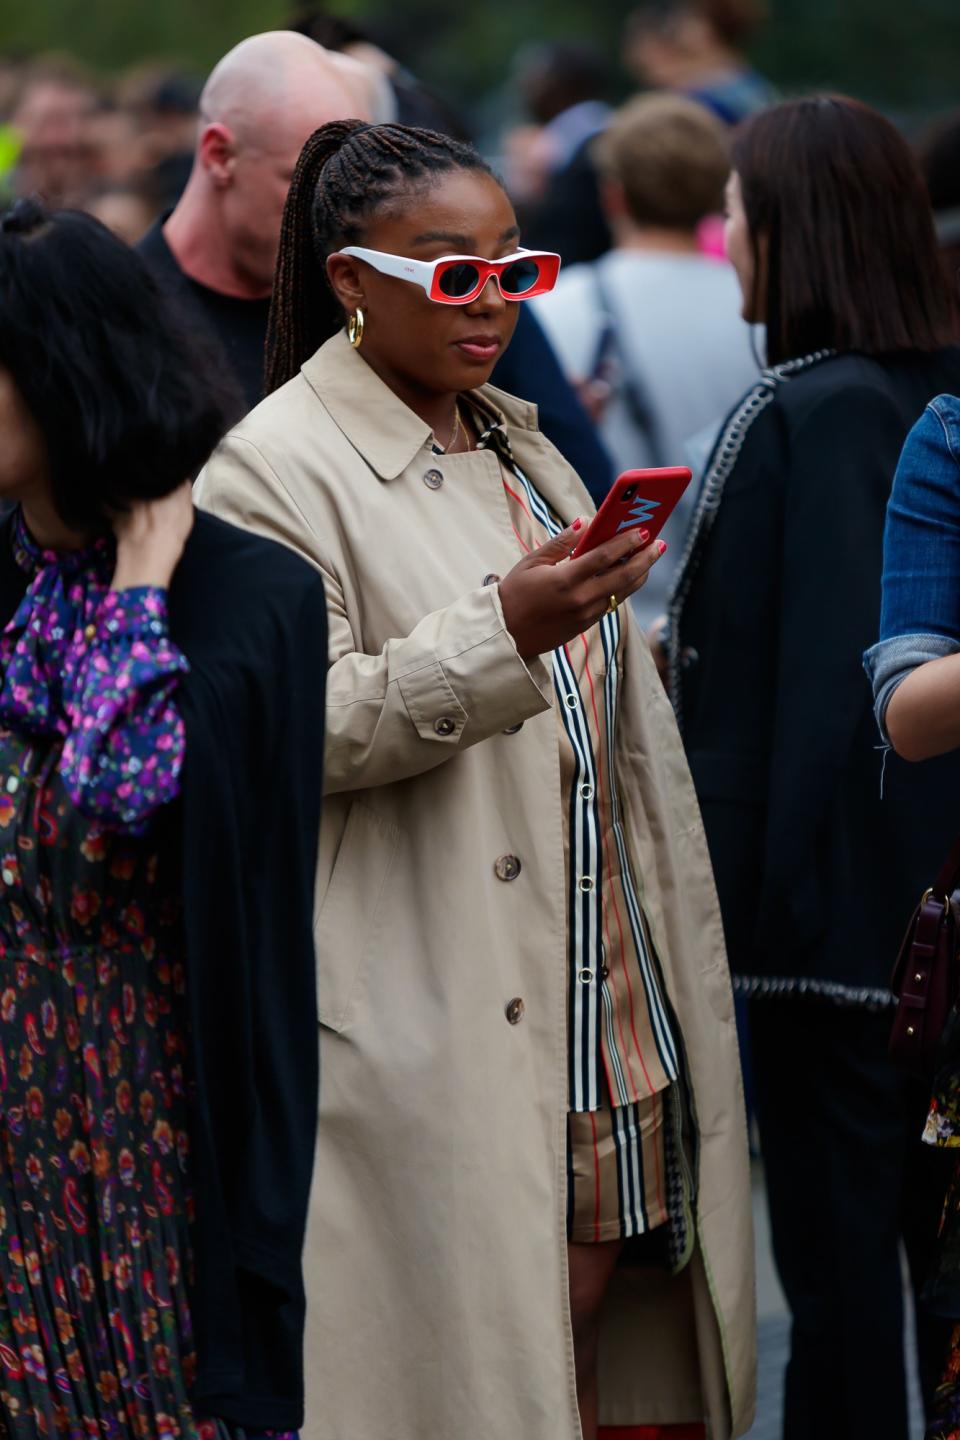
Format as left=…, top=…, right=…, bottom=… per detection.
left=138, top=30, right=383, bottom=419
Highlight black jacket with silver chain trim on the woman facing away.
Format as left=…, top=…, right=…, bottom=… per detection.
left=674, top=348, right=960, bottom=999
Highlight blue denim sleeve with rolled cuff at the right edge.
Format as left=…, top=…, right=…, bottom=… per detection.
left=864, top=395, right=960, bottom=743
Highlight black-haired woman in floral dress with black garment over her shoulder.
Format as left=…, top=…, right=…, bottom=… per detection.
left=0, top=200, right=325, bottom=1440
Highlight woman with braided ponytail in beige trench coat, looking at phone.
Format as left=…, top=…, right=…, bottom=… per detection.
left=192, top=122, right=753, bottom=1440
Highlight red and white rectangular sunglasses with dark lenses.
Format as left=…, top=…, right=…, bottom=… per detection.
left=340, top=245, right=560, bottom=305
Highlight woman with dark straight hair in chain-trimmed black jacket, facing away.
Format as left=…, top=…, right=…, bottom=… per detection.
left=668, top=96, right=960, bottom=1440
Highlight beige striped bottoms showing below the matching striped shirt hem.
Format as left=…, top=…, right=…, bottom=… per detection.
left=567, top=1092, right=669, bottom=1244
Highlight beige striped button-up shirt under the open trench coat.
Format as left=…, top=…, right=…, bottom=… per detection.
left=479, top=411, right=679, bottom=1112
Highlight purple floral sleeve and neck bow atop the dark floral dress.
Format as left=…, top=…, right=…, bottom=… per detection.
left=0, top=511, right=190, bottom=834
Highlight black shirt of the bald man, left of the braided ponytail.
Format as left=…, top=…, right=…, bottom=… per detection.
left=137, top=215, right=271, bottom=422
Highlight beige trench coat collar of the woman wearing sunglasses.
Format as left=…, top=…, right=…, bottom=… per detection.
left=301, top=330, right=537, bottom=480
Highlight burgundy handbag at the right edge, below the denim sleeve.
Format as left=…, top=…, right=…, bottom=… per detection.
left=889, top=840, right=960, bottom=1079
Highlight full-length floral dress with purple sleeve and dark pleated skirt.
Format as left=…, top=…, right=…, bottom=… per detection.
left=0, top=516, right=296, bottom=1440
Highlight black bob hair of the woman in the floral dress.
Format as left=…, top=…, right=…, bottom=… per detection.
left=0, top=200, right=226, bottom=528
